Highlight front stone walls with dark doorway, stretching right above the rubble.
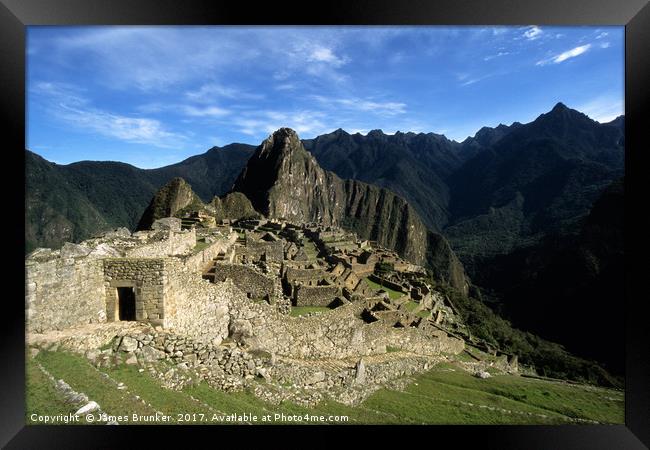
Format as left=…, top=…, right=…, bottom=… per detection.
left=25, top=214, right=464, bottom=358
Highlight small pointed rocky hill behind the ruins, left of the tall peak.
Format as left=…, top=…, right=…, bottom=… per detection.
left=137, top=177, right=203, bottom=230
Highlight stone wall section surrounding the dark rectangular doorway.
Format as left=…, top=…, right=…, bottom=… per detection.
left=103, top=258, right=165, bottom=325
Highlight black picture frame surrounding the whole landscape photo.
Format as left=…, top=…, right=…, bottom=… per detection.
left=0, top=0, right=650, bottom=449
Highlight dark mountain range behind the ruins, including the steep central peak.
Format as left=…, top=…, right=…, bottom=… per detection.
left=26, top=103, right=625, bottom=376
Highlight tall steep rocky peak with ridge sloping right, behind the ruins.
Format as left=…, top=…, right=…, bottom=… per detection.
left=233, top=128, right=467, bottom=290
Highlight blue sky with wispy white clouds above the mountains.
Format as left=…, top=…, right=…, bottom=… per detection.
left=26, top=25, right=624, bottom=168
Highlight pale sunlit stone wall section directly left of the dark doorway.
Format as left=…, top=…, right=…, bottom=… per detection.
left=25, top=257, right=106, bottom=332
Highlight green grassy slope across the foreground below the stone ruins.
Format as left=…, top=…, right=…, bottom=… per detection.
left=27, top=352, right=624, bottom=424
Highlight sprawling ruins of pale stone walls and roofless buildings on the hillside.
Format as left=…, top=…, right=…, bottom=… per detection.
left=25, top=218, right=512, bottom=403
